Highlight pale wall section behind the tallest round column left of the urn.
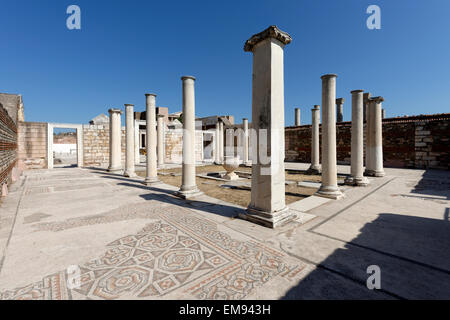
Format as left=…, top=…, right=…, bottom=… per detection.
left=164, top=129, right=203, bottom=163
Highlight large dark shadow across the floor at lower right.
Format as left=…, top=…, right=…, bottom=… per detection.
left=282, top=212, right=450, bottom=299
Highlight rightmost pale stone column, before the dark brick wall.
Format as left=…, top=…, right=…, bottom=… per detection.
left=365, top=97, right=385, bottom=177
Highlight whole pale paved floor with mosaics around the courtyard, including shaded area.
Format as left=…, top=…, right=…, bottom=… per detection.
left=0, top=163, right=450, bottom=299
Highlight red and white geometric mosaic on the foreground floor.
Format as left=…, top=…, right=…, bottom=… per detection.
left=0, top=205, right=305, bottom=300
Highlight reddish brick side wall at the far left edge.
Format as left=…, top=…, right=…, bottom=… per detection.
left=0, top=104, right=17, bottom=186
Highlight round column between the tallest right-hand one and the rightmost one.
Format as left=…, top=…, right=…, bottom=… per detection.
left=345, top=90, right=369, bottom=187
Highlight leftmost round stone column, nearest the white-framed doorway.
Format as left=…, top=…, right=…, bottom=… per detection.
left=108, top=109, right=122, bottom=172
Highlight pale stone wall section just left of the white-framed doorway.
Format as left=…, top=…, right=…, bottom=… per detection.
left=18, top=122, right=48, bottom=170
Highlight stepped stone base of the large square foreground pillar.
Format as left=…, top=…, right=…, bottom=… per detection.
left=239, top=207, right=297, bottom=229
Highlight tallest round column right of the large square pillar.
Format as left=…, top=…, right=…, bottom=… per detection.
left=316, top=74, right=343, bottom=199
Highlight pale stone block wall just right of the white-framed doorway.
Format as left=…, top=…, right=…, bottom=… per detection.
left=83, top=124, right=126, bottom=167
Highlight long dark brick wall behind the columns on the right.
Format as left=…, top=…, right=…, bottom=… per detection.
left=285, top=114, right=450, bottom=170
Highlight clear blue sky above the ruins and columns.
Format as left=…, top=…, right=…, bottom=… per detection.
left=0, top=0, right=450, bottom=125
